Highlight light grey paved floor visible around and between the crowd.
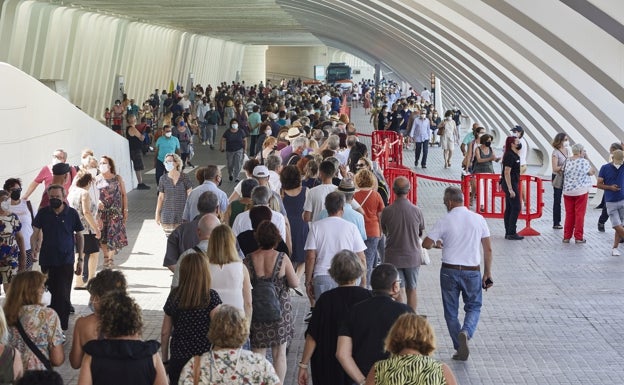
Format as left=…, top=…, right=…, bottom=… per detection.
left=18, top=109, right=624, bottom=385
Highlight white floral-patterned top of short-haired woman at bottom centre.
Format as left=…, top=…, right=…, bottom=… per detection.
left=179, top=348, right=280, bottom=385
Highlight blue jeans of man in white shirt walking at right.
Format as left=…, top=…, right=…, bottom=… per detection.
left=440, top=268, right=482, bottom=349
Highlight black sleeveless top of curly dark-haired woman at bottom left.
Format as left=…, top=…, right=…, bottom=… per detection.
left=84, top=340, right=160, bottom=385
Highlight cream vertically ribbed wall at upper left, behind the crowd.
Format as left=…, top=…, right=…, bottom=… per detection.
left=0, top=0, right=245, bottom=118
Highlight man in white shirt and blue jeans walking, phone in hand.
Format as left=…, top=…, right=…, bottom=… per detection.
left=423, top=187, right=493, bottom=361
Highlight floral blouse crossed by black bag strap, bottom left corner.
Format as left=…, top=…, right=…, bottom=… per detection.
left=9, top=305, right=63, bottom=370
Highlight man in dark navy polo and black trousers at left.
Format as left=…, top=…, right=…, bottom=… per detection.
left=30, top=184, right=84, bottom=330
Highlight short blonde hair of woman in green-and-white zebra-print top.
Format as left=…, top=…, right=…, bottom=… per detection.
left=384, top=313, right=435, bottom=356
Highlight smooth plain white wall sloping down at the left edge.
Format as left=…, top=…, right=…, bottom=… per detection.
left=0, top=62, right=136, bottom=207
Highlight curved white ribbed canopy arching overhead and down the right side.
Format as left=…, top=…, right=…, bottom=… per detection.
left=8, top=0, right=624, bottom=165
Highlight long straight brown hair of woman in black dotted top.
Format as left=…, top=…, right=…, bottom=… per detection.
left=174, top=252, right=212, bottom=309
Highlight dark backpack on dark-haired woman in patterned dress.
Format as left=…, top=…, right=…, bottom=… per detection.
left=248, top=253, right=284, bottom=322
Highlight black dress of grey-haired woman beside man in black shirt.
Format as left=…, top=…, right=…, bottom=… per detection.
left=306, top=286, right=372, bottom=385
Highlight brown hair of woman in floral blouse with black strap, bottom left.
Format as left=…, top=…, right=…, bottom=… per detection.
left=4, top=270, right=47, bottom=326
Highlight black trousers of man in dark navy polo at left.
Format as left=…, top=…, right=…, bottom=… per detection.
left=41, top=264, right=74, bottom=330
